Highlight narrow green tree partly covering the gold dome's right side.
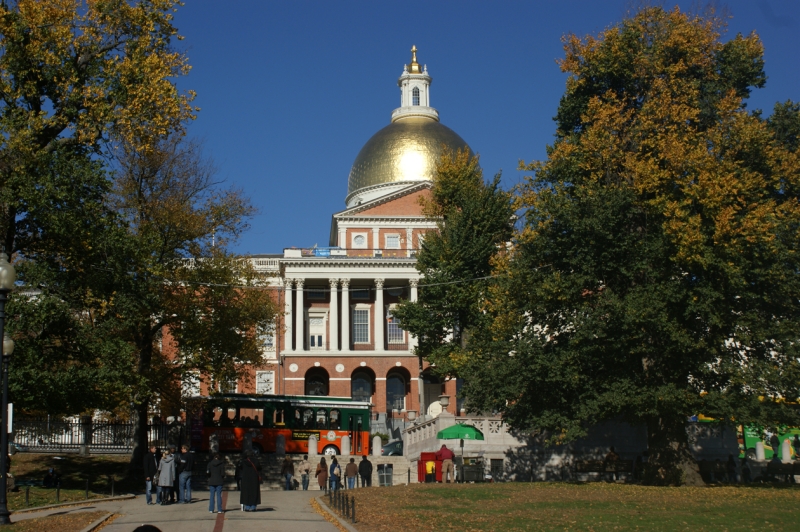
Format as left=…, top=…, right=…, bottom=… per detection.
left=393, top=150, right=514, bottom=402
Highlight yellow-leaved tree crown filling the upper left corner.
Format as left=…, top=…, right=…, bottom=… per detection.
left=0, top=0, right=195, bottom=253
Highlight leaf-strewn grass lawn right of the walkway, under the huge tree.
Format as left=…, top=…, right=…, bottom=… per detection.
left=345, top=482, right=800, bottom=532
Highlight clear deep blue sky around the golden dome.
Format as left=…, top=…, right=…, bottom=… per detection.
left=176, top=0, right=800, bottom=253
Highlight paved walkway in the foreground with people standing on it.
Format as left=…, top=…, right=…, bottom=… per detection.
left=11, top=490, right=337, bottom=532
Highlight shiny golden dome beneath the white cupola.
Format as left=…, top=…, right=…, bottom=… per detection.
left=347, top=117, right=472, bottom=197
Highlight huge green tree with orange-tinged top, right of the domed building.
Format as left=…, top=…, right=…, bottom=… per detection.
left=456, top=7, right=800, bottom=484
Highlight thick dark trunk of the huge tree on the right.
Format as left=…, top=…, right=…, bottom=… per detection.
left=644, top=417, right=705, bottom=486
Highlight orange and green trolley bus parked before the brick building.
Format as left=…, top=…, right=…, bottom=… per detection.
left=187, top=394, right=372, bottom=455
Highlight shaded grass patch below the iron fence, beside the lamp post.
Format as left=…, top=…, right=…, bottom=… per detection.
left=8, top=453, right=138, bottom=511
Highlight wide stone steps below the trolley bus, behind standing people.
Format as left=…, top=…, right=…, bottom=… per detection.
left=192, top=453, right=417, bottom=490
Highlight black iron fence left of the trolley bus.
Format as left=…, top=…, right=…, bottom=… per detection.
left=11, top=417, right=187, bottom=453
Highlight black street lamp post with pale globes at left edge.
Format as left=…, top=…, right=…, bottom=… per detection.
left=0, top=252, right=17, bottom=525
